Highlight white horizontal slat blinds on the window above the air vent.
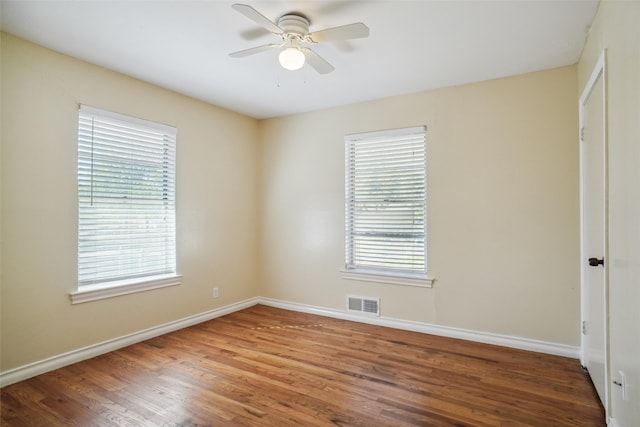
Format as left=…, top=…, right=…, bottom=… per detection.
left=345, top=127, right=427, bottom=275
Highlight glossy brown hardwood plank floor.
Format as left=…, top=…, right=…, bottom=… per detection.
left=0, top=305, right=605, bottom=427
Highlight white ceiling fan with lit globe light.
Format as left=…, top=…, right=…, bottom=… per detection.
left=229, top=3, right=369, bottom=74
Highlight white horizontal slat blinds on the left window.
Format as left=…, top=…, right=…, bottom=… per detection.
left=78, top=106, right=176, bottom=286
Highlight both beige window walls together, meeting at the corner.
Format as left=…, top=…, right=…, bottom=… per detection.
left=0, top=34, right=579, bottom=371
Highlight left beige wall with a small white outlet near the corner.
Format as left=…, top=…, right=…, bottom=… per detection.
left=0, top=34, right=258, bottom=371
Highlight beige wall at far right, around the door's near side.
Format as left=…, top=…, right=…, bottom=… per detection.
left=578, top=1, right=640, bottom=427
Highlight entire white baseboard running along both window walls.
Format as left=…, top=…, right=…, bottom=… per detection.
left=0, top=297, right=580, bottom=390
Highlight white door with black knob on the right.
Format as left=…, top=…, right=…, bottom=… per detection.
left=580, top=53, right=609, bottom=414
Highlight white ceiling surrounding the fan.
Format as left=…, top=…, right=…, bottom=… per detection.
left=0, top=0, right=598, bottom=118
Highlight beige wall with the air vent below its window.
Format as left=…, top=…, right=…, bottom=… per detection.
left=260, top=67, right=580, bottom=346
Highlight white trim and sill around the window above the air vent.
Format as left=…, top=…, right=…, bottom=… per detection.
left=340, top=125, right=435, bottom=288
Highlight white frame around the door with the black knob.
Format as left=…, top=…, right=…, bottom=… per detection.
left=579, top=49, right=611, bottom=423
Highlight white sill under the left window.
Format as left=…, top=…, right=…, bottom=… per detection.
left=69, top=274, right=182, bottom=304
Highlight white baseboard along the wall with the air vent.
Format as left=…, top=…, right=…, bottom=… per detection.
left=260, top=298, right=580, bottom=359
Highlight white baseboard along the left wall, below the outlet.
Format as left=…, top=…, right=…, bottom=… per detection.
left=0, top=298, right=260, bottom=387
